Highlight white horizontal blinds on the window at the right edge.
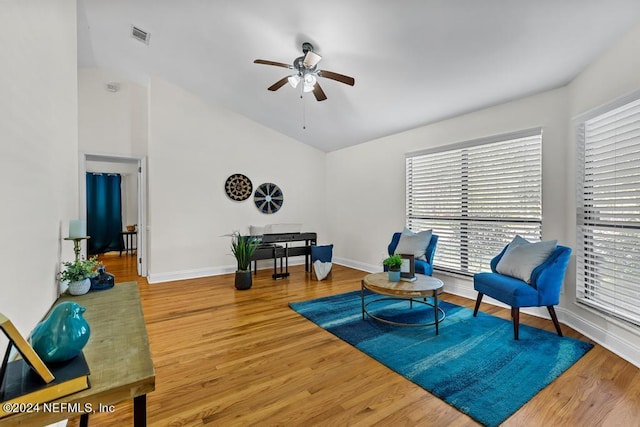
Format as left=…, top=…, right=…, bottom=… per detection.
left=576, top=99, right=640, bottom=325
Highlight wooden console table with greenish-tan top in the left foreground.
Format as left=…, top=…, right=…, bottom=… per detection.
left=0, top=282, right=155, bottom=427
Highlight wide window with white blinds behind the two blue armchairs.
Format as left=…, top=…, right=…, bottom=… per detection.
left=406, top=129, right=542, bottom=276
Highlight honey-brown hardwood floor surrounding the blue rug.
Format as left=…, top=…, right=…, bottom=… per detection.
left=70, top=254, right=640, bottom=426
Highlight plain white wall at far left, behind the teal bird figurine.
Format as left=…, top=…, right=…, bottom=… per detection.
left=0, top=0, right=78, bottom=348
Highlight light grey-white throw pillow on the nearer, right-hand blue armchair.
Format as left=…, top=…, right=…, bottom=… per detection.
left=496, top=236, right=558, bottom=283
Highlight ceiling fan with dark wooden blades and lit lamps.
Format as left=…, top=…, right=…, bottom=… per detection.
left=253, top=42, right=356, bottom=101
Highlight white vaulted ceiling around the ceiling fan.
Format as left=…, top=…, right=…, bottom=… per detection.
left=78, top=0, right=640, bottom=152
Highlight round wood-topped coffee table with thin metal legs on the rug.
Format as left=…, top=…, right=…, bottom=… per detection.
left=360, top=273, right=446, bottom=335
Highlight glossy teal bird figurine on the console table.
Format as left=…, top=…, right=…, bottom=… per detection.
left=31, top=301, right=91, bottom=363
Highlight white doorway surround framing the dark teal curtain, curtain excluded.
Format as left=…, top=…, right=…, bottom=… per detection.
left=79, top=153, right=148, bottom=277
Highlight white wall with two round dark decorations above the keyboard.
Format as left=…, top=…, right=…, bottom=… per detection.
left=148, top=78, right=326, bottom=282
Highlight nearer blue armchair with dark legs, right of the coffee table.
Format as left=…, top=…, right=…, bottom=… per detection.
left=473, top=245, right=571, bottom=340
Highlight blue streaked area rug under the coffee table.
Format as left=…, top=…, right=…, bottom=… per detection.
left=289, top=291, right=593, bottom=426
